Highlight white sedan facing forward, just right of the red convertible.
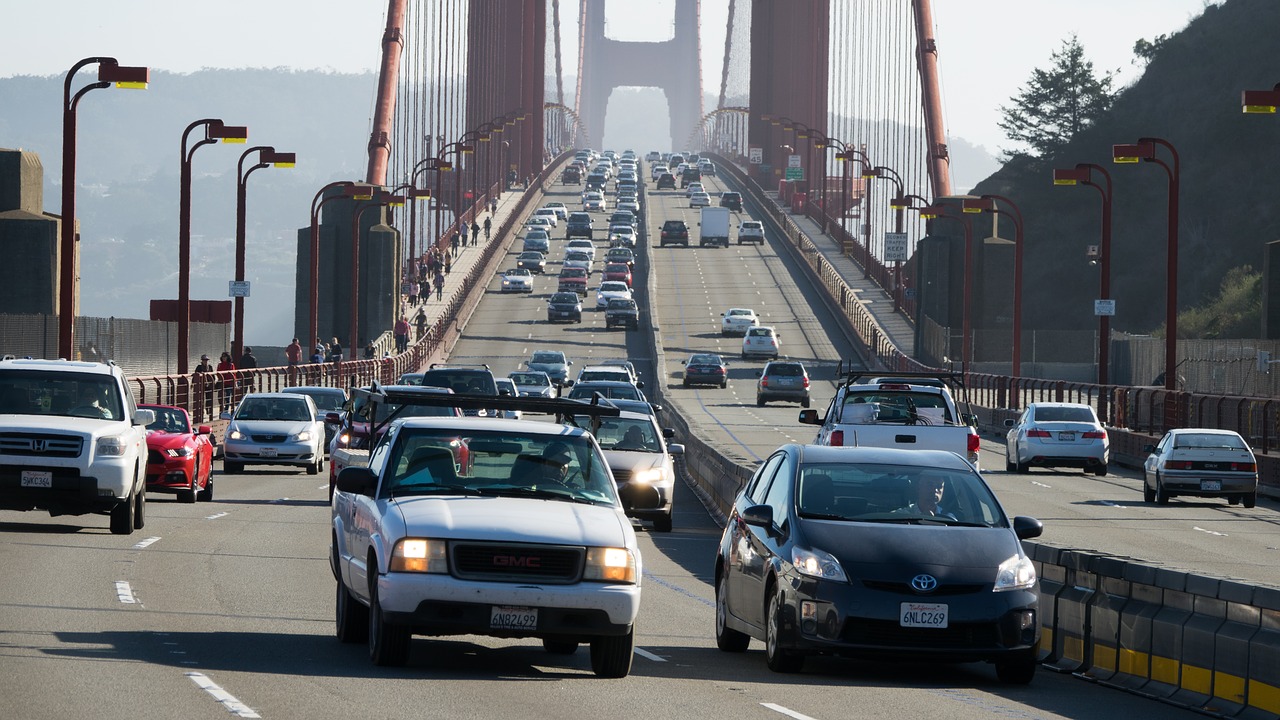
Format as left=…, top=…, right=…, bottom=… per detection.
left=220, top=392, right=325, bottom=475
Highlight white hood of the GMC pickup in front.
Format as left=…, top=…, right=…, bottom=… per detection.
left=389, top=496, right=635, bottom=547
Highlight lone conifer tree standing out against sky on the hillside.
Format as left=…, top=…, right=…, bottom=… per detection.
left=998, top=35, right=1115, bottom=160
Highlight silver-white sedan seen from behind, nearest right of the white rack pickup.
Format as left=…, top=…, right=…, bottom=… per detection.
left=1005, top=402, right=1111, bottom=475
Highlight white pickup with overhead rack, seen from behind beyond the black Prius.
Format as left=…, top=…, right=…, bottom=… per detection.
left=800, top=372, right=979, bottom=468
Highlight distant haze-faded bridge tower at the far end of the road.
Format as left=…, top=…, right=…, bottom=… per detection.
left=577, top=0, right=703, bottom=150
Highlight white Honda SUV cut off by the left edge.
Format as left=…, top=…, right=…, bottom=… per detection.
left=0, top=360, right=155, bottom=536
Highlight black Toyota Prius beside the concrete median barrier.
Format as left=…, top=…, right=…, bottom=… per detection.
left=716, top=445, right=1042, bottom=683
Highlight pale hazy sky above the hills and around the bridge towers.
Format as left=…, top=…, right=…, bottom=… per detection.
left=0, top=0, right=1217, bottom=152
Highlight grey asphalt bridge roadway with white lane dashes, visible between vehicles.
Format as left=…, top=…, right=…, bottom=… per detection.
left=0, top=162, right=1259, bottom=720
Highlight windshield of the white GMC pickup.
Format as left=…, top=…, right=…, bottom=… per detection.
left=379, top=427, right=618, bottom=506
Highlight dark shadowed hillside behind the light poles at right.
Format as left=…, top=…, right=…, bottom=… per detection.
left=974, top=0, right=1280, bottom=337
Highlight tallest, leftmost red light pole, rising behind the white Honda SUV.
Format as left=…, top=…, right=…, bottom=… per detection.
left=58, top=58, right=151, bottom=360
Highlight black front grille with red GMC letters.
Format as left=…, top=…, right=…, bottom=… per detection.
left=449, top=542, right=585, bottom=584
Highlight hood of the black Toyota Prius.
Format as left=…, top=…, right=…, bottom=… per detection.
left=800, top=519, right=1020, bottom=584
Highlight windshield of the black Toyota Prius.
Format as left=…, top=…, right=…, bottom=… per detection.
left=796, top=462, right=1006, bottom=528
